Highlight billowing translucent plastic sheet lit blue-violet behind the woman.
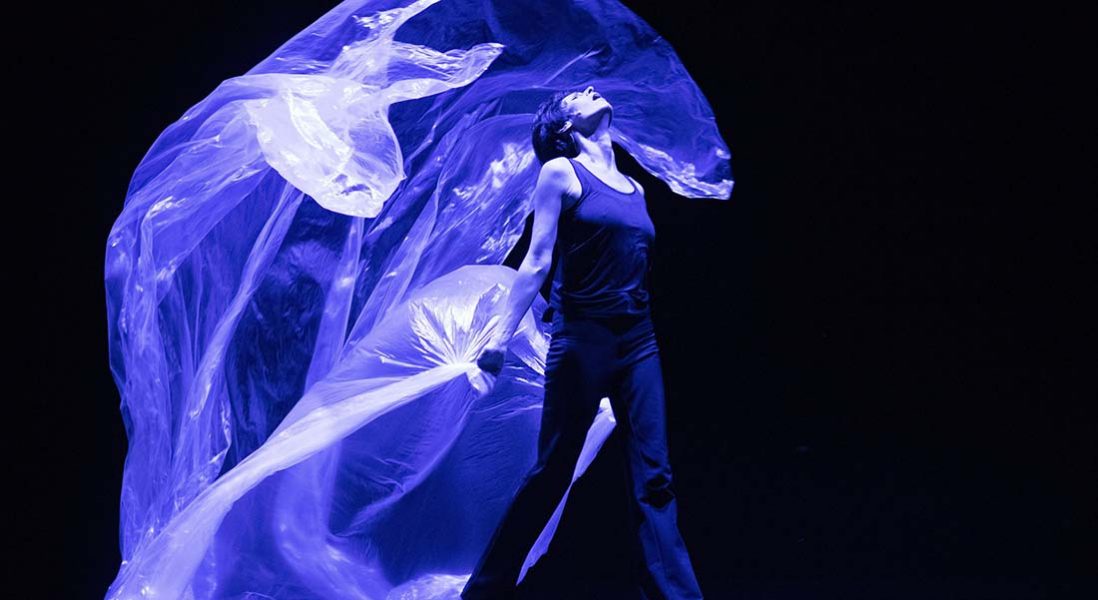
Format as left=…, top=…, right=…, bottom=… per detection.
left=105, top=0, right=732, bottom=599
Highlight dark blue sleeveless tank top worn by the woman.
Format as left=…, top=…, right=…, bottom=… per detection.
left=542, top=158, right=656, bottom=321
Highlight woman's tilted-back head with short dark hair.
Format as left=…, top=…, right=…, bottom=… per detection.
left=533, top=86, right=613, bottom=164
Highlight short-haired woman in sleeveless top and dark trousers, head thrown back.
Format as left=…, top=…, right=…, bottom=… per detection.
left=461, top=86, right=702, bottom=600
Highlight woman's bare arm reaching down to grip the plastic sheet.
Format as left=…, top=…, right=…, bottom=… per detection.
left=478, top=158, right=574, bottom=375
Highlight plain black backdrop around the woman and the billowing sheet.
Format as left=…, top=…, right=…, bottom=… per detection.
left=21, top=0, right=1098, bottom=600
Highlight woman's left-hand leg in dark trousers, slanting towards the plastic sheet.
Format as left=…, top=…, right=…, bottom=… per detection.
left=461, top=325, right=613, bottom=600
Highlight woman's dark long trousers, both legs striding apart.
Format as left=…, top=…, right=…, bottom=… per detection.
left=461, top=313, right=702, bottom=600
